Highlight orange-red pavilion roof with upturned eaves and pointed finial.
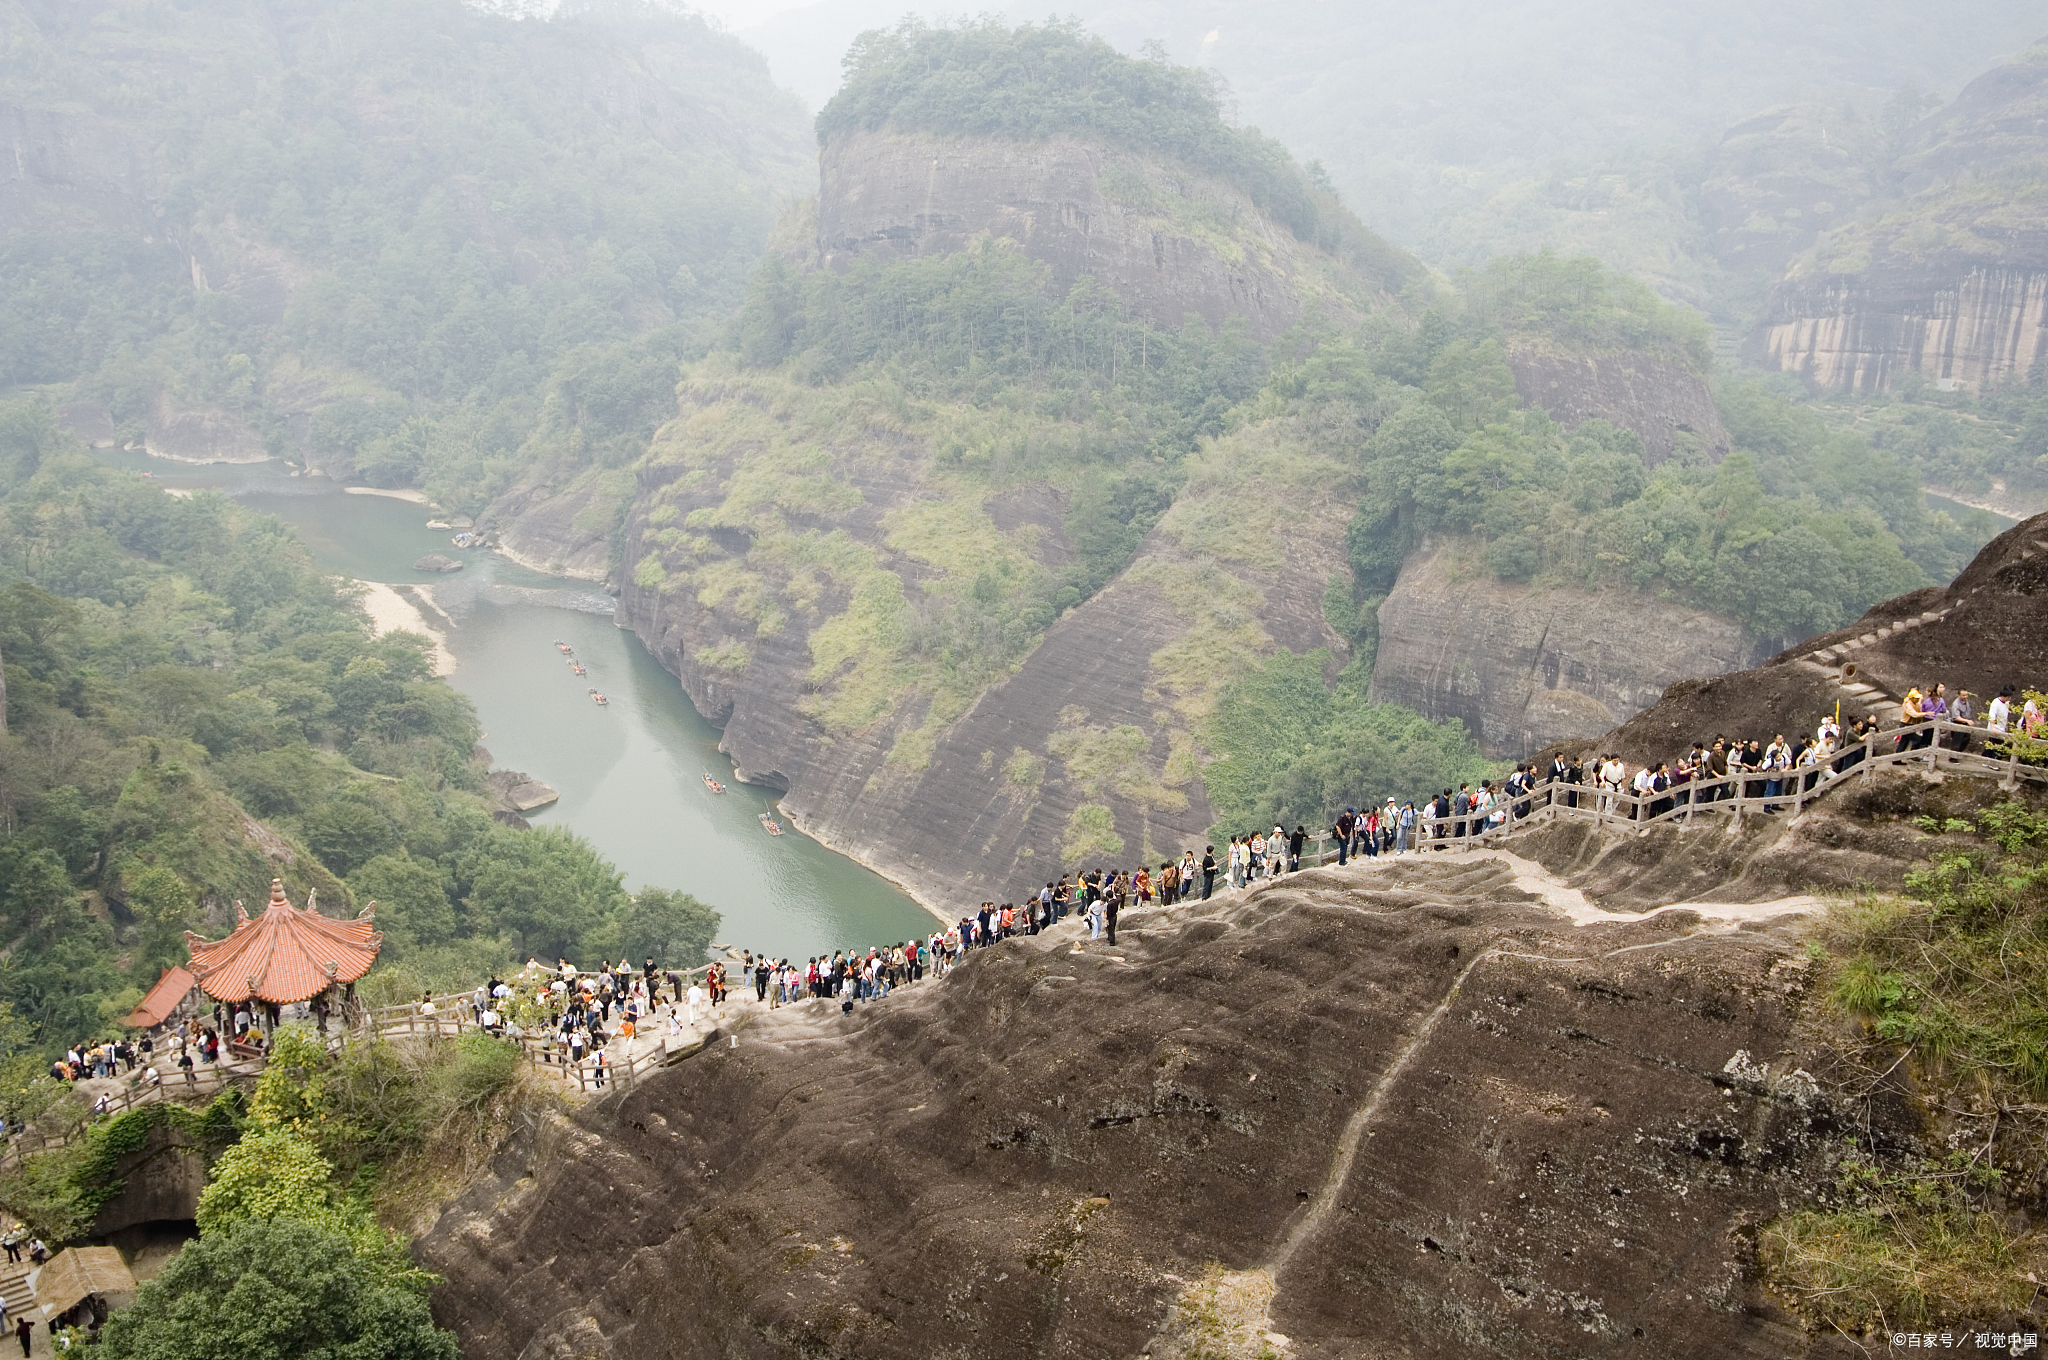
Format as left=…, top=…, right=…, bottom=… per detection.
left=184, top=879, right=383, bottom=1006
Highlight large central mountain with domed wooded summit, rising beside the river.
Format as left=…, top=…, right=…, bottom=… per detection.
left=581, top=23, right=1987, bottom=909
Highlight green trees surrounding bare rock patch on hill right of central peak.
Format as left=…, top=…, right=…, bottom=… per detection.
left=1325, top=305, right=1980, bottom=641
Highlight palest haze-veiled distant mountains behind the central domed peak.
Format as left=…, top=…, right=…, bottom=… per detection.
left=741, top=0, right=2048, bottom=288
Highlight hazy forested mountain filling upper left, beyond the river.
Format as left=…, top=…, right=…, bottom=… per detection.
left=0, top=0, right=809, bottom=508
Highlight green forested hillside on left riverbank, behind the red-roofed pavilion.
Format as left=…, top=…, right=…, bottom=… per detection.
left=0, top=401, right=715, bottom=1073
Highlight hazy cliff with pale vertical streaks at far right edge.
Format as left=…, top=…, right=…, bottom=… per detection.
left=1747, top=47, right=2048, bottom=391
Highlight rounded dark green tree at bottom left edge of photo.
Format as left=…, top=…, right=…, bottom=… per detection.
left=102, top=1219, right=461, bottom=1360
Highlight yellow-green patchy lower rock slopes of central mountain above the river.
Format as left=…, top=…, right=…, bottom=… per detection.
left=618, top=379, right=1350, bottom=909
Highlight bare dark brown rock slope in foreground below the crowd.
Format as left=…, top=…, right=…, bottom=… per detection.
left=422, top=858, right=1855, bottom=1360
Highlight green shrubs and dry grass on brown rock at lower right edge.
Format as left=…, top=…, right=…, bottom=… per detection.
left=1759, top=801, right=2048, bottom=1331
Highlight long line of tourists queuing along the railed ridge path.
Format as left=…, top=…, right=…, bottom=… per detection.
left=24, top=684, right=2048, bottom=1133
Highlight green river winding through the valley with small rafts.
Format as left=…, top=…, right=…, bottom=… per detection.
left=98, top=453, right=932, bottom=963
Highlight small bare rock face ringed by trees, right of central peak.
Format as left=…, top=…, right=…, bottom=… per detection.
left=1507, top=348, right=1729, bottom=465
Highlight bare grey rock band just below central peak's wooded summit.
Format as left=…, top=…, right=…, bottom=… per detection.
left=817, top=131, right=1423, bottom=340
